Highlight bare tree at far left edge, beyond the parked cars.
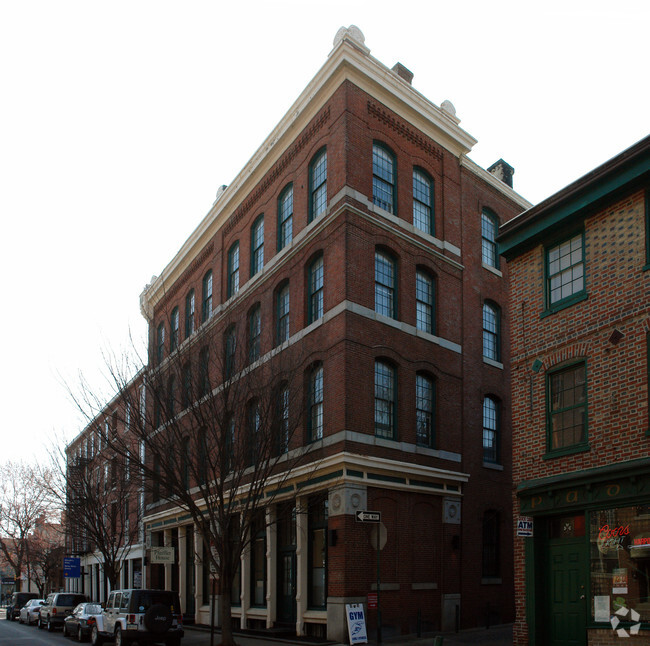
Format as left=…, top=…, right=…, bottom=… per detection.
left=0, top=462, right=54, bottom=590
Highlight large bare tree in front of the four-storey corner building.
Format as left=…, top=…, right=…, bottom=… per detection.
left=73, top=313, right=322, bottom=646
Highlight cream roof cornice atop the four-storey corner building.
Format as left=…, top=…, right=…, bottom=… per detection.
left=140, top=31, right=476, bottom=317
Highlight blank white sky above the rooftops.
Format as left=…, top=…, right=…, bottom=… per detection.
left=0, top=0, right=650, bottom=461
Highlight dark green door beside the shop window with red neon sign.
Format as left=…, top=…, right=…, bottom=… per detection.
left=546, top=539, right=587, bottom=646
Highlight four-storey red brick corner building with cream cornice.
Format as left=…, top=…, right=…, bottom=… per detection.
left=67, top=27, right=530, bottom=640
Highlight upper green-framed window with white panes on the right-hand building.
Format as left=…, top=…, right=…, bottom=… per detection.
left=545, top=231, right=587, bottom=312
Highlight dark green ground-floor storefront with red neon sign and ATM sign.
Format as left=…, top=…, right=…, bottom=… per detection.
left=514, top=459, right=650, bottom=646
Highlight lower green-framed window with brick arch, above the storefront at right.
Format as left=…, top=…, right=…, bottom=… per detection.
left=546, top=361, right=588, bottom=453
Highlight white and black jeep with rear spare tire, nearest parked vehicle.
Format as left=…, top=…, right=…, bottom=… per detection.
left=90, top=589, right=184, bottom=646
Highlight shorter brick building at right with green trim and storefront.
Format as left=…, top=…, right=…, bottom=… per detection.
left=499, top=138, right=650, bottom=646
